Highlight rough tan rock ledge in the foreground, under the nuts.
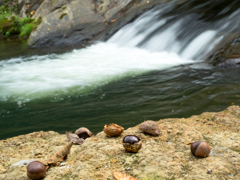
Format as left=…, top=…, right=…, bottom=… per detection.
left=0, top=106, right=240, bottom=180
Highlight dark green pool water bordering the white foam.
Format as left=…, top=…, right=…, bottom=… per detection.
left=0, top=39, right=240, bottom=139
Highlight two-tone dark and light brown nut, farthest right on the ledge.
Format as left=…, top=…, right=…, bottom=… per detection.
left=191, top=141, right=211, bottom=157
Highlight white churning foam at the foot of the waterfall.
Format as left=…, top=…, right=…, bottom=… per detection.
left=0, top=43, right=192, bottom=102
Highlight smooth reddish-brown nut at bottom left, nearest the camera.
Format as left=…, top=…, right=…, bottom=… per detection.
left=27, top=161, right=47, bottom=179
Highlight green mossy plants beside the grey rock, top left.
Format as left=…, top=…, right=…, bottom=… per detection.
left=0, top=6, right=41, bottom=38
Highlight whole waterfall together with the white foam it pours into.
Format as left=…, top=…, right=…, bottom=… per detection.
left=0, top=1, right=240, bottom=102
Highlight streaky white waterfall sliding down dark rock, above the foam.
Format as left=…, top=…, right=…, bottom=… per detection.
left=108, top=0, right=240, bottom=61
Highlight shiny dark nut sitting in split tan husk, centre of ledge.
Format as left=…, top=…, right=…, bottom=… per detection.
left=123, top=135, right=142, bottom=153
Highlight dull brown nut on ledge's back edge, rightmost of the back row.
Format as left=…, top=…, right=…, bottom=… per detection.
left=139, top=120, right=160, bottom=136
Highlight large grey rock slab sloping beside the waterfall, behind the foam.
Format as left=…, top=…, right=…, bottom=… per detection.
left=28, top=0, right=171, bottom=47
